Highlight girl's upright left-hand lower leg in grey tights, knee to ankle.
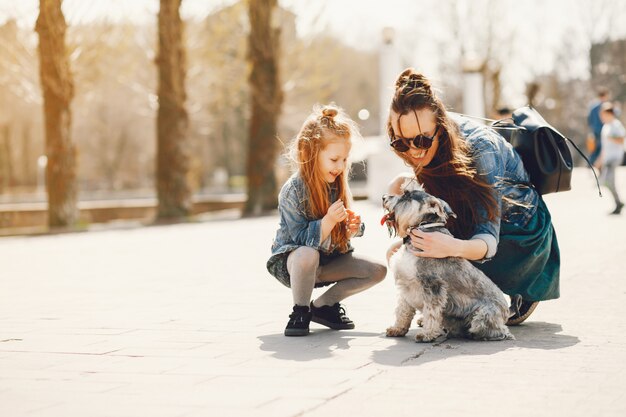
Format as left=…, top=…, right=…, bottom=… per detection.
left=287, top=246, right=320, bottom=307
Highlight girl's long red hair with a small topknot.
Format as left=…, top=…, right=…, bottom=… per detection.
left=290, top=104, right=360, bottom=252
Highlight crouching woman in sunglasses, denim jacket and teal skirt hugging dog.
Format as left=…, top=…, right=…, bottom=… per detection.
left=387, top=68, right=560, bottom=325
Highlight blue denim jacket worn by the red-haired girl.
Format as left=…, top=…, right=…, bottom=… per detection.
left=272, top=172, right=365, bottom=256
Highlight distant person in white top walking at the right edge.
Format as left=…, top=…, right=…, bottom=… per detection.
left=598, top=101, right=626, bottom=214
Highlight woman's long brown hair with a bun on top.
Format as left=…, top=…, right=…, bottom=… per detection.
left=387, top=68, right=500, bottom=239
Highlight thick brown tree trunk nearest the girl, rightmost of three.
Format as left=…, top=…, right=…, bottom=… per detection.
left=244, top=0, right=283, bottom=215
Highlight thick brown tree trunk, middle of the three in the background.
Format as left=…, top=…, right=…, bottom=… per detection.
left=156, top=0, right=191, bottom=219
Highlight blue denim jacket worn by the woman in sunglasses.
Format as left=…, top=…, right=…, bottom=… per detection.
left=451, top=115, right=540, bottom=261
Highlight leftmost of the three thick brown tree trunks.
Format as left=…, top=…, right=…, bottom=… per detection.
left=35, top=0, right=78, bottom=227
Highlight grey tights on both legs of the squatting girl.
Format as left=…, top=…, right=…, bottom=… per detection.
left=287, top=246, right=387, bottom=307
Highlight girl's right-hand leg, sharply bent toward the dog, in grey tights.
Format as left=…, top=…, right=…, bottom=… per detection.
left=314, top=252, right=387, bottom=307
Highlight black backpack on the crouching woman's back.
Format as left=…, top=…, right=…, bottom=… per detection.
left=491, top=106, right=602, bottom=196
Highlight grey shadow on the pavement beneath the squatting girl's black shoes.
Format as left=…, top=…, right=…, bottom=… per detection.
left=258, top=329, right=380, bottom=361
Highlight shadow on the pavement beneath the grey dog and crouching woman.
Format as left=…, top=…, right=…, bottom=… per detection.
left=372, top=322, right=580, bottom=366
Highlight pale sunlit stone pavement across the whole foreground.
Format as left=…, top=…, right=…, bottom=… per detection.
left=0, top=168, right=626, bottom=417
